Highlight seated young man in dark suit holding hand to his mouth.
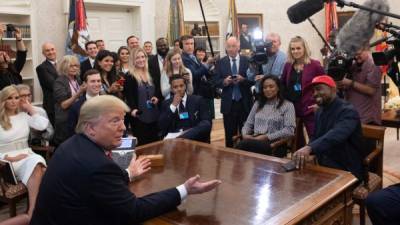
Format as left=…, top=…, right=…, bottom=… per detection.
left=158, top=75, right=211, bottom=142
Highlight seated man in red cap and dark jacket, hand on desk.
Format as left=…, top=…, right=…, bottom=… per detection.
left=294, top=75, right=363, bottom=180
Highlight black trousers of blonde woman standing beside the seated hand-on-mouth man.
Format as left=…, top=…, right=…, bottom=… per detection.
left=131, top=118, right=159, bottom=146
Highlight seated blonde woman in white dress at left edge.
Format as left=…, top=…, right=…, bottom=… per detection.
left=0, top=85, right=49, bottom=217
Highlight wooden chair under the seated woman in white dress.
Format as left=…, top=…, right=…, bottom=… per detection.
left=0, top=161, right=29, bottom=217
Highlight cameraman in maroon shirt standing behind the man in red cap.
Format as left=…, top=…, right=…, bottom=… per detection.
left=337, top=46, right=381, bottom=125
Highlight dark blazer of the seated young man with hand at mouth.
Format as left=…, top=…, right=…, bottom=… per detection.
left=158, top=95, right=211, bottom=142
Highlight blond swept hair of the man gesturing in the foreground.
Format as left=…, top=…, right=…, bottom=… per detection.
left=75, top=95, right=130, bottom=133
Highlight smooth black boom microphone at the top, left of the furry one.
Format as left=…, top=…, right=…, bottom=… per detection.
left=286, top=0, right=325, bottom=24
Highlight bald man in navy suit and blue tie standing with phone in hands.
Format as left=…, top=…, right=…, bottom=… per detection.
left=216, top=37, right=254, bottom=147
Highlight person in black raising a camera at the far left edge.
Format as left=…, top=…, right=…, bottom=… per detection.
left=0, top=24, right=27, bottom=90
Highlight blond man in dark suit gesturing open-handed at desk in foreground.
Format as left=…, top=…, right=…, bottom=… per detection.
left=30, top=95, right=221, bottom=225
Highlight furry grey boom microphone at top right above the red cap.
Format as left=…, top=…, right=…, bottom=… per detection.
left=336, top=0, right=389, bottom=57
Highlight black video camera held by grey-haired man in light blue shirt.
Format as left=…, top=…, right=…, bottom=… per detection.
left=249, top=40, right=272, bottom=74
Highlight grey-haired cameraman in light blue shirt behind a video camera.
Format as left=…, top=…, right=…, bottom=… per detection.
left=247, top=33, right=286, bottom=93
